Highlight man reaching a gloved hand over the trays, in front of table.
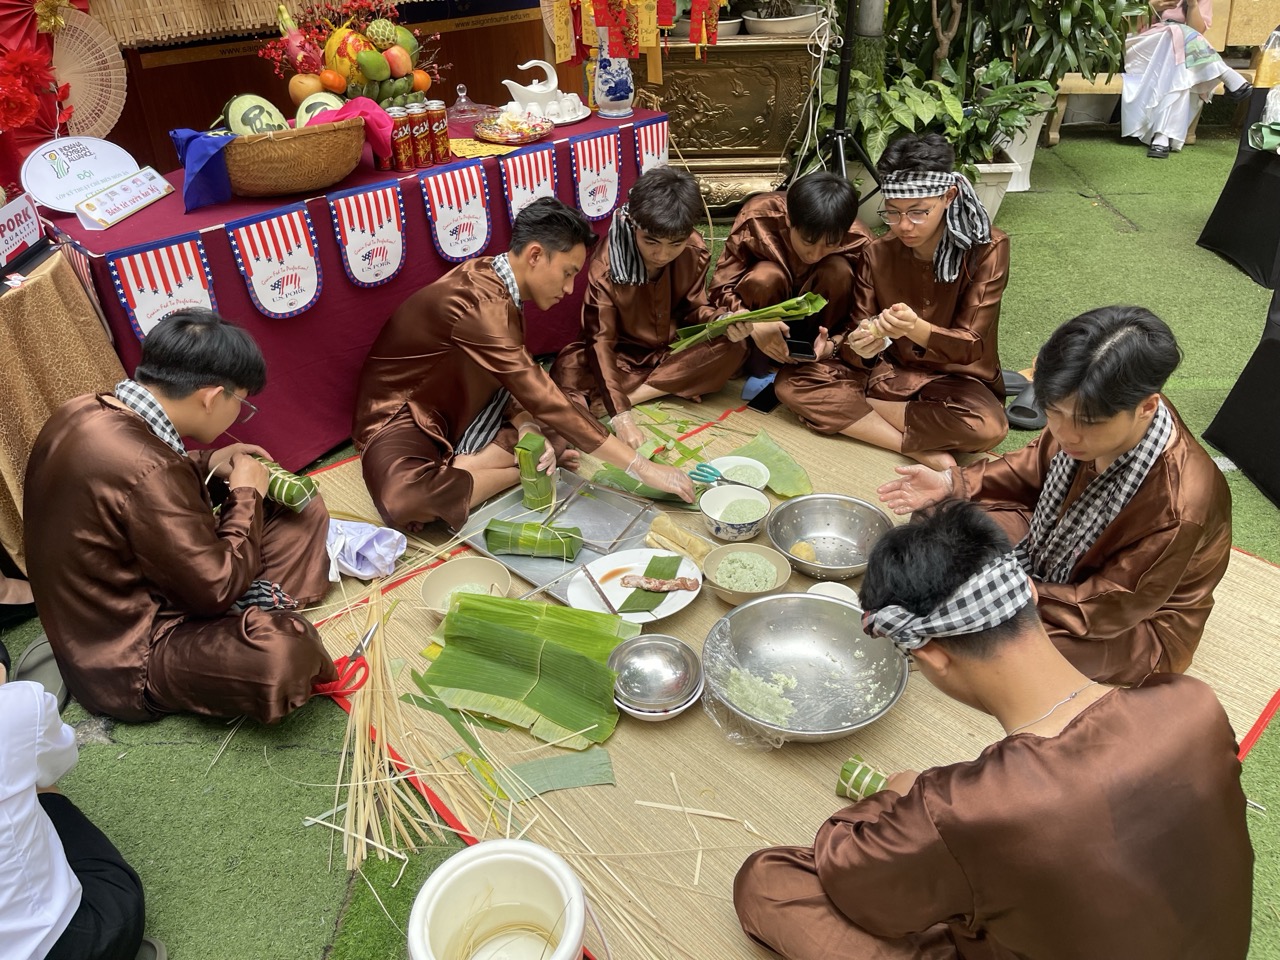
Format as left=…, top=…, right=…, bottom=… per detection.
left=352, top=197, right=694, bottom=531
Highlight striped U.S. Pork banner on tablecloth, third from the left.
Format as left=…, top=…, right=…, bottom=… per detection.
left=328, top=180, right=406, bottom=287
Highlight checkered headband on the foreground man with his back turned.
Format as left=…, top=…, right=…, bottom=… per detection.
left=863, top=552, right=1032, bottom=652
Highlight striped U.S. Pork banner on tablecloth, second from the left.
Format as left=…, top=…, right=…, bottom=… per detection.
left=227, top=204, right=324, bottom=319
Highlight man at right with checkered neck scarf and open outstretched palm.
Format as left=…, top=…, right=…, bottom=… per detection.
left=879, top=306, right=1231, bottom=684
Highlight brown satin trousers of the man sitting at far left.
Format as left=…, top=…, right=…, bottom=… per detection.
left=143, top=498, right=338, bottom=723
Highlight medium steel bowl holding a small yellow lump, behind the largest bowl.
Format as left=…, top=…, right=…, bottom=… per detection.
left=767, top=493, right=893, bottom=580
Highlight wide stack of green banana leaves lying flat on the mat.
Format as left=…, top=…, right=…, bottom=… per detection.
left=415, top=598, right=618, bottom=750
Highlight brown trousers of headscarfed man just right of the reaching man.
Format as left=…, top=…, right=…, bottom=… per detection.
left=552, top=337, right=746, bottom=416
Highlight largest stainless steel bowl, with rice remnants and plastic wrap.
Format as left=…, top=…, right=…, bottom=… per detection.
left=703, top=594, right=908, bottom=742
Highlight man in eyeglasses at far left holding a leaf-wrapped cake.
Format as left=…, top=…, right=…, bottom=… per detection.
left=23, top=308, right=337, bottom=723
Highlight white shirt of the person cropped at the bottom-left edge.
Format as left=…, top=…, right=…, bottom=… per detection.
left=0, top=680, right=81, bottom=960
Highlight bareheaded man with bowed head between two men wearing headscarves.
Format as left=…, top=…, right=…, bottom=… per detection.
left=710, top=170, right=872, bottom=376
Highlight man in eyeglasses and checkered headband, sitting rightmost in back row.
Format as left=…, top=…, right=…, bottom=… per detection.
left=776, top=133, right=1009, bottom=470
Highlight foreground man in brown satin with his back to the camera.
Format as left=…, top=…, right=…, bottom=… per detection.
left=733, top=500, right=1253, bottom=960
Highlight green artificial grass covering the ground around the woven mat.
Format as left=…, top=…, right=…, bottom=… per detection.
left=4, top=129, right=1280, bottom=960
